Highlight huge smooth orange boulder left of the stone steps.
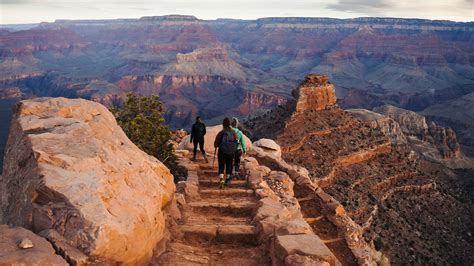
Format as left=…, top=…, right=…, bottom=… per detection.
left=0, top=98, right=175, bottom=263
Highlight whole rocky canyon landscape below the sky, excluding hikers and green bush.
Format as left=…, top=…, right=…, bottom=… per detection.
left=0, top=15, right=474, bottom=265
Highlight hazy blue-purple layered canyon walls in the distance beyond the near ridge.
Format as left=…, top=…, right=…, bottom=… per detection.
left=0, top=15, right=474, bottom=154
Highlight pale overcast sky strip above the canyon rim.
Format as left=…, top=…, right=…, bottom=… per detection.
left=0, top=0, right=474, bottom=24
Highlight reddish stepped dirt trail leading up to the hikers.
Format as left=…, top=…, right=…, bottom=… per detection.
left=153, top=157, right=271, bottom=265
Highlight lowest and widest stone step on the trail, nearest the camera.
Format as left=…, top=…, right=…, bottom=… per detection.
left=179, top=224, right=258, bottom=245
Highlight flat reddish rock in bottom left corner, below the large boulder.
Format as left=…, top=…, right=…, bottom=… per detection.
left=0, top=224, right=68, bottom=266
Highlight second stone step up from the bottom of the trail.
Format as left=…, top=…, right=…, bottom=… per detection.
left=188, top=199, right=257, bottom=217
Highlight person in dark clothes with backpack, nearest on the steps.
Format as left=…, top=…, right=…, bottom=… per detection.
left=214, top=117, right=238, bottom=188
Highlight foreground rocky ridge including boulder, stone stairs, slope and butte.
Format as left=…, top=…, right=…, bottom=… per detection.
left=0, top=74, right=474, bottom=265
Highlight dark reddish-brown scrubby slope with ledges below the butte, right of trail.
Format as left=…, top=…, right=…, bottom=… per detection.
left=244, top=75, right=474, bottom=264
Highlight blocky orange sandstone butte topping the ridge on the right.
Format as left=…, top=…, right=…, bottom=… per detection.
left=294, top=74, right=336, bottom=112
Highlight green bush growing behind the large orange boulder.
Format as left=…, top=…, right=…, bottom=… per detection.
left=111, top=92, right=177, bottom=174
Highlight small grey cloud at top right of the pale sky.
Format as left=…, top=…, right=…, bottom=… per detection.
left=327, top=0, right=394, bottom=15
